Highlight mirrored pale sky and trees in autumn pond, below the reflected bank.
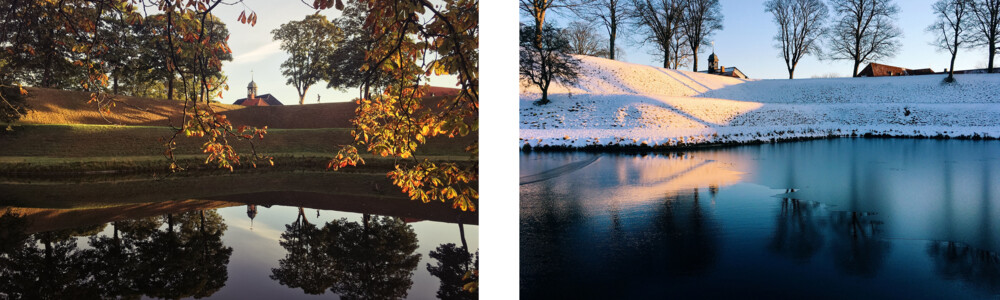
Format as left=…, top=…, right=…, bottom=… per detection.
left=0, top=200, right=479, bottom=299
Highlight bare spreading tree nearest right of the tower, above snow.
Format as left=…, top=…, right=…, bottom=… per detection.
left=764, top=0, right=829, bottom=79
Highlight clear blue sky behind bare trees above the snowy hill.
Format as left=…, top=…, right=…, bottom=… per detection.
left=536, top=0, right=987, bottom=79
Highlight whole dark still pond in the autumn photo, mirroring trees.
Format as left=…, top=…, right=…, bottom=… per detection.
left=0, top=175, right=479, bottom=299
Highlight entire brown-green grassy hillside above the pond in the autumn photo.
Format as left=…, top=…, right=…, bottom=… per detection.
left=0, top=88, right=478, bottom=177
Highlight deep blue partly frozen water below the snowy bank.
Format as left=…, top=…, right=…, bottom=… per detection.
left=520, top=138, right=1000, bottom=299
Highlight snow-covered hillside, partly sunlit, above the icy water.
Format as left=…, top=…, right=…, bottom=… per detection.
left=520, top=56, right=1000, bottom=147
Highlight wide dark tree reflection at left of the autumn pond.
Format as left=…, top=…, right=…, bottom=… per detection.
left=0, top=210, right=232, bottom=299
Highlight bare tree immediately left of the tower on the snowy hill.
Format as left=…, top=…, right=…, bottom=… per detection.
left=681, top=0, right=722, bottom=72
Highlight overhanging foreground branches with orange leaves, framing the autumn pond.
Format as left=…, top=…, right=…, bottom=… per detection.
left=0, top=0, right=479, bottom=210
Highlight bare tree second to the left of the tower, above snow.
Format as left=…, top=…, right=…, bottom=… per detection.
left=632, top=0, right=684, bottom=68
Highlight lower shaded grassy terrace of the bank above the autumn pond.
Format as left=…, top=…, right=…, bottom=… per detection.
left=0, top=125, right=476, bottom=175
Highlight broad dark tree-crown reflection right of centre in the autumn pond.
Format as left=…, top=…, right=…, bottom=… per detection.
left=271, top=210, right=420, bottom=299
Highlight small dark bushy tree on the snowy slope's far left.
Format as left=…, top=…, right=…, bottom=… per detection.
left=520, top=24, right=579, bottom=105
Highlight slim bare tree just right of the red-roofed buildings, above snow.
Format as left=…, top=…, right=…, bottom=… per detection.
left=927, top=0, right=972, bottom=82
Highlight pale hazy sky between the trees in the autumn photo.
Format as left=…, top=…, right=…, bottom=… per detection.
left=213, top=0, right=455, bottom=105
